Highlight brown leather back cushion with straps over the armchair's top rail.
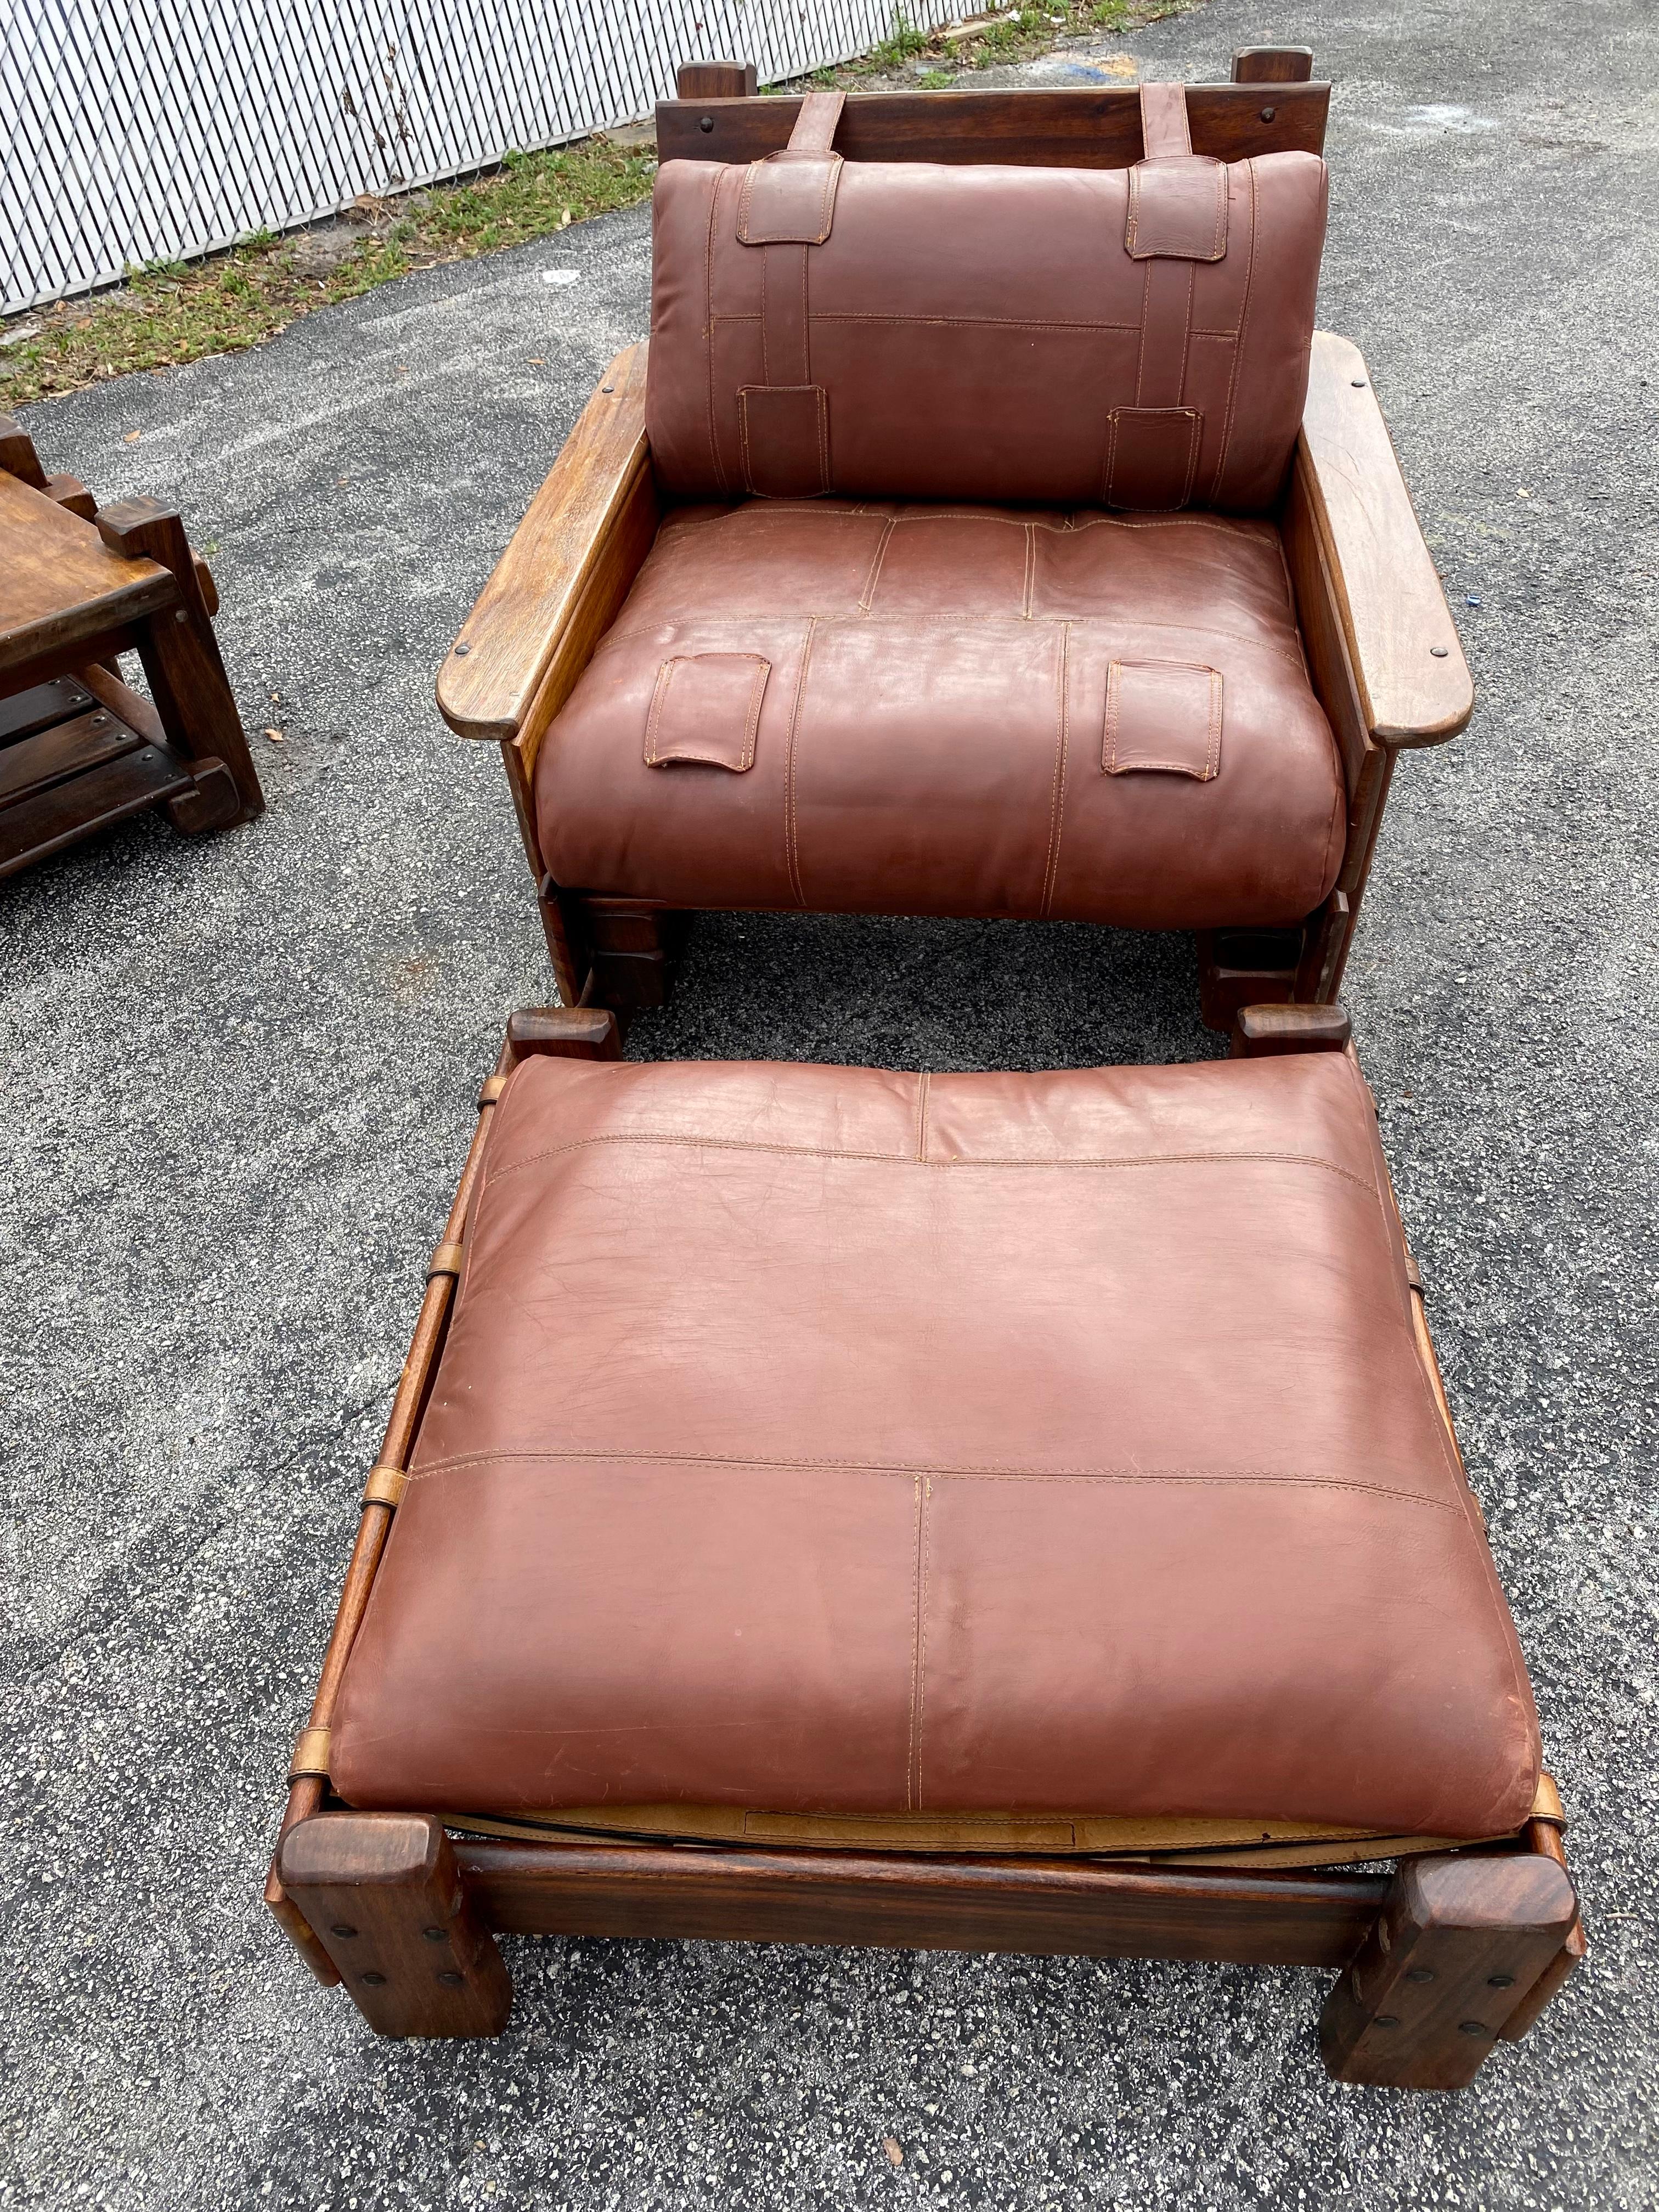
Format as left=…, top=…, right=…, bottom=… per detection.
left=646, top=150, right=1325, bottom=513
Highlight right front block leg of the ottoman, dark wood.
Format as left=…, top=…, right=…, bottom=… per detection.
left=1318, top=1852, right=1577, bottom=2088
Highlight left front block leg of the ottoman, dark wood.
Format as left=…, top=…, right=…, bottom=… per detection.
left=281, top=1812, right=513, bottom=2035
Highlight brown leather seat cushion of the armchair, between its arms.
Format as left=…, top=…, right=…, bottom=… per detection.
left=535, top=502, right=1345, bottom=929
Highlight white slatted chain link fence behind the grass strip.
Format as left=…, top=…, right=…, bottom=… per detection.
left=0, top=0, right=960, bottom=314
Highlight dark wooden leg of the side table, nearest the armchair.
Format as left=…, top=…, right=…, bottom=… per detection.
left=97, top=500, right=266, bottom=816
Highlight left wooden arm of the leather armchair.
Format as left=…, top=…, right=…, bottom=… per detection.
left=438, top=345, right=657, bottom=747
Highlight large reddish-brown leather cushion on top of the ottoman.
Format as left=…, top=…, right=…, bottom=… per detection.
left=332, top=1055, right=1539, bottom=1836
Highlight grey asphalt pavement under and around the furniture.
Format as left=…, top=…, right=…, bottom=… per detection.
left=0, top=0, right=1659, bottom=2212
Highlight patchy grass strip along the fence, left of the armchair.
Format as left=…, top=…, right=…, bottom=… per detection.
left=0, top=139, right=657, bottom=414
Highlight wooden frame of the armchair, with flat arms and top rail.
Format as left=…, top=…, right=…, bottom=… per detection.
left=438, top=49, right=1473, bottom=1029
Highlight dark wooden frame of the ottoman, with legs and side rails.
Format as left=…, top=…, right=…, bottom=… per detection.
left=266, top=1005, right=1584, bottom=2088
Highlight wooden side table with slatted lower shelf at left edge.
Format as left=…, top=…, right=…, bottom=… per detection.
left=0, top=416, right=266, bottom=876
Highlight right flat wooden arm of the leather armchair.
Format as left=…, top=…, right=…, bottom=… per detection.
left=1296, top=330, right=1475, bottom=746
